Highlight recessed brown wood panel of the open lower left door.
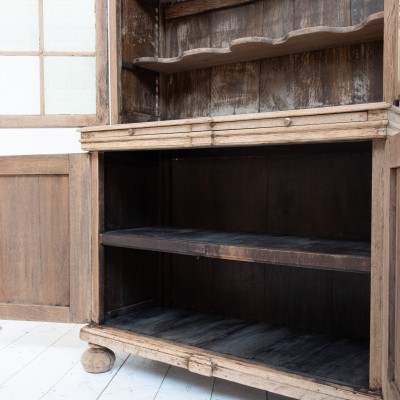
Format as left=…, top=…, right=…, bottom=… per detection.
left=0, top=173, right=70, bottom=307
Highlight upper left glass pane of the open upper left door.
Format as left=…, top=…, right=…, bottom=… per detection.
left=0, top=0, right=39, bottom=51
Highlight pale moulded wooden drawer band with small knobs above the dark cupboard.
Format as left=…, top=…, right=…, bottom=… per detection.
left=79, top=102, right=390, bottom=151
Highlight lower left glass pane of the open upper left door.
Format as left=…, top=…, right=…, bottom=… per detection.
left=0, top=56, right=40, bottom=115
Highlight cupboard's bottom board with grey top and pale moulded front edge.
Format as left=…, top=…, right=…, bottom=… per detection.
left=81, top=307, right=373, bottom=399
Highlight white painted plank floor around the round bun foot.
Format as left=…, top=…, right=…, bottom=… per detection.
left=0, top=320, right=286, bottom=400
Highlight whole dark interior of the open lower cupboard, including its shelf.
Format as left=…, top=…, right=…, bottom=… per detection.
left=102, top=142, right=371, bottom=388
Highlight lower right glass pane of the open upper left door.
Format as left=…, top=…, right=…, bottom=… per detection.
left=44, top=57, right=96, bottom=114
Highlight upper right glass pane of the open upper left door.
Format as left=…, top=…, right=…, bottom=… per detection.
left=43, top=0, right=95, bottom=52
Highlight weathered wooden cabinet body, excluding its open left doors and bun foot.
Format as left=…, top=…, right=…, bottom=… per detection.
left=3, top=0, right=400, bottom=400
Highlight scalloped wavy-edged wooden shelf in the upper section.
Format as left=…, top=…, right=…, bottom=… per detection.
left=133, top=11, right=383, bottom=74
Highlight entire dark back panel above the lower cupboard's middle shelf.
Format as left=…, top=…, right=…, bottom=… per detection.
left=169, top=143, right=371, bottom=241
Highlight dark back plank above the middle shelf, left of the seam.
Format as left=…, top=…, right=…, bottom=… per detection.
left=171, top=155, right=267, bottom=233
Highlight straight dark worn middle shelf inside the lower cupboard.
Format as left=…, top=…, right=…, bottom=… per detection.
left=101, top=227, right=371, bottom=273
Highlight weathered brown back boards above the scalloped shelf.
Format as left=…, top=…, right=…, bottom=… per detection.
left=164, top=0, right=383, bottom=57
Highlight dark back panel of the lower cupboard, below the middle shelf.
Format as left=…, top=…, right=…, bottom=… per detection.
left=162, top=255, right=370, bottom=340
